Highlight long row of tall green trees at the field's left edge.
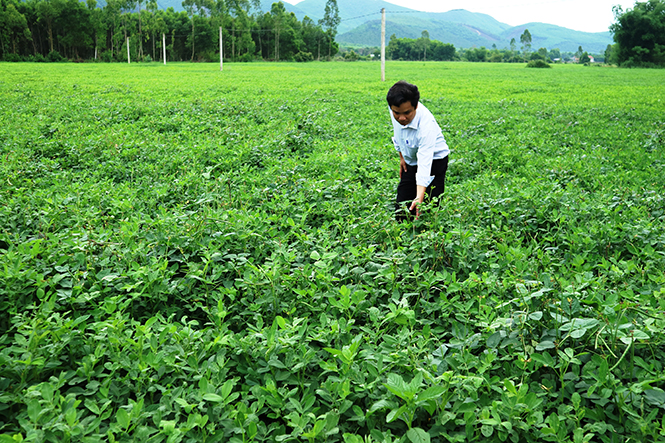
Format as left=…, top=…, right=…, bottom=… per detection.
left=0, top=0, right=340, bottom=62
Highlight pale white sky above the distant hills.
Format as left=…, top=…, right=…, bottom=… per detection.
left=287, top=0, right=635, bottom=32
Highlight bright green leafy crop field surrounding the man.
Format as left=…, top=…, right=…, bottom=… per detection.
left=0, top=62, right=665, bottom=443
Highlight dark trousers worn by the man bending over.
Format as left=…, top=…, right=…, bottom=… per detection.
left=395, top=156, right=448, bottom=222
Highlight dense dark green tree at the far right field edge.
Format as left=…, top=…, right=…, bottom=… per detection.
left=610, top=0, right=665, bottom=67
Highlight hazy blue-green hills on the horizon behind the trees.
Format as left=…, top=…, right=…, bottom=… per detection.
left=134, top=0, right=613, bottom=53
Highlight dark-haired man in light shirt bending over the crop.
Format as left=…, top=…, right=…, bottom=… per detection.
left=386, top=81, right=450, bottom=222
